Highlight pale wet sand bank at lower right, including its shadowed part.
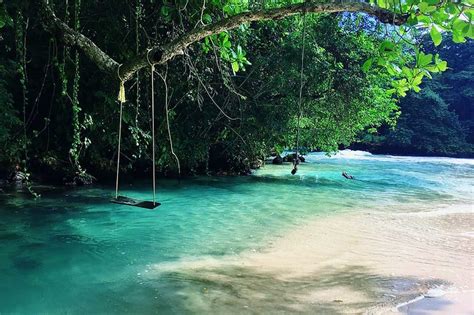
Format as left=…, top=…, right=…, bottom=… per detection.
left=154, top=205, right=474, bottom=314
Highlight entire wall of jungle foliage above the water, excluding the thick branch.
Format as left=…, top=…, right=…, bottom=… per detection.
left=0, top=0, right=474, bottom=183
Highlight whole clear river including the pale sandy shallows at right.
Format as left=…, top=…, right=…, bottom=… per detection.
left=0, top=150, right=474, bottom=314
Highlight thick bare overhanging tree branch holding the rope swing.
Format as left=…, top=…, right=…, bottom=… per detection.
left=39, top=0, right=408, bottom=81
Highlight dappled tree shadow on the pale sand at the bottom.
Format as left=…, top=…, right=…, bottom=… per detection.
left=129, top=264, right=447, bottom=314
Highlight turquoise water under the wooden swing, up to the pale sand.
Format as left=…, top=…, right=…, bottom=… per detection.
left=0, top=151, right=474, bottom=314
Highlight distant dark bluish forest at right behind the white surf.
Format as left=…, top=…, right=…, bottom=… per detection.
left=360, top=39, right=474, bottom=157
